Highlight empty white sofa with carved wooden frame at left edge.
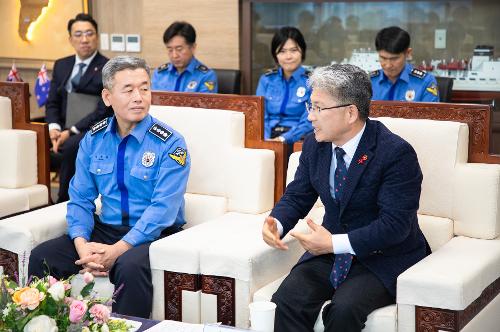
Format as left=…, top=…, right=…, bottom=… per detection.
left=0, top=96, right=48, bottom=218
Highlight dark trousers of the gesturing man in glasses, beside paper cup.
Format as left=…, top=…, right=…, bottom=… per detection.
left=272, top=255, right=395, bottom=332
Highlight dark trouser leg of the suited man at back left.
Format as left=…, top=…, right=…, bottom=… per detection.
left=57, top=133, right=85, bottom=203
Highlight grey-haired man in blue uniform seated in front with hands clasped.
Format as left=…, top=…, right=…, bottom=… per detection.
left=28, top=56, right=190, bottom=318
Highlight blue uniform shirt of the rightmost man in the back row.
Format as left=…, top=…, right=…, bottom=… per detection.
left=370, top=63, right=439, bottom=102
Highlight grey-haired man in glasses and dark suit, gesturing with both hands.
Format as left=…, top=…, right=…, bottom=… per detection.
left=262, top=65, right=428, bottom=332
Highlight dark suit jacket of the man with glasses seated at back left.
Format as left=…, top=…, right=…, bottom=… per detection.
left=45, top=52, right=113, bottom=132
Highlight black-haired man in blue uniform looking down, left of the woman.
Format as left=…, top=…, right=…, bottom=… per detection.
left=151, top=22, right=217, bottom=93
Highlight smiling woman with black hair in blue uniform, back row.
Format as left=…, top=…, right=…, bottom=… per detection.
left=256, top=27, right=313, bottom=144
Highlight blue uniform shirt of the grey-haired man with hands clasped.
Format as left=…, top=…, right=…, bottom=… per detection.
left=66, top=115, right=190, bottom=246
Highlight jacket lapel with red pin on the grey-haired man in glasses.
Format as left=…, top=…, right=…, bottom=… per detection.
left=340, top=119, right=376, bottom=214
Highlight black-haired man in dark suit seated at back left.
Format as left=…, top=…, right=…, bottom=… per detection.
left=45, top=14, right=113, bottom=202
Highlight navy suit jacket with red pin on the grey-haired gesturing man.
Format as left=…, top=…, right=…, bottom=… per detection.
left=271, top=120, right=428, bottom=295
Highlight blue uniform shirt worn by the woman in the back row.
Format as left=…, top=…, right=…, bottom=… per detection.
left=256, top=67, right=313, bottom=143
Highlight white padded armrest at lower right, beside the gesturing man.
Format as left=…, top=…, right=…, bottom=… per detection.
left=397, top=236, right=500, bottom=310
